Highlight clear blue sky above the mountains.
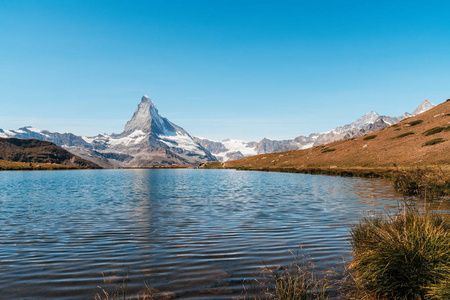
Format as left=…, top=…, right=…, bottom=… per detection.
left=0, top=0, right=450, bottom=140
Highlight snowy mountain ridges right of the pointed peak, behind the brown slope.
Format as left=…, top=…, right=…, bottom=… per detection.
left=194, top=99, right=435, bottom=162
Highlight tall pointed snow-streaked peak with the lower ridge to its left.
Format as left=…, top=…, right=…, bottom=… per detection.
left=0, top=95, right=216, bottom=168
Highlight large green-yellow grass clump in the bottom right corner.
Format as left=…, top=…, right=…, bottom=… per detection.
left=349, top=208, right=450, bottom=299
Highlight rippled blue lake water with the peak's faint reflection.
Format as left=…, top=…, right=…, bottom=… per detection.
left=0, top=170, right=403, bottom=299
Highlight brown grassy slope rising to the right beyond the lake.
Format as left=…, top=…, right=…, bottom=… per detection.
left=224, top=101, right=450, bottom=171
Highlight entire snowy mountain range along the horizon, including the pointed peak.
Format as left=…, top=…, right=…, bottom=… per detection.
left=0, top=95, right=435, bottom=168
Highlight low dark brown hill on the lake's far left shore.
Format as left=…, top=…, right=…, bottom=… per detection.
left=0, top=138, right=100, bottom=169
